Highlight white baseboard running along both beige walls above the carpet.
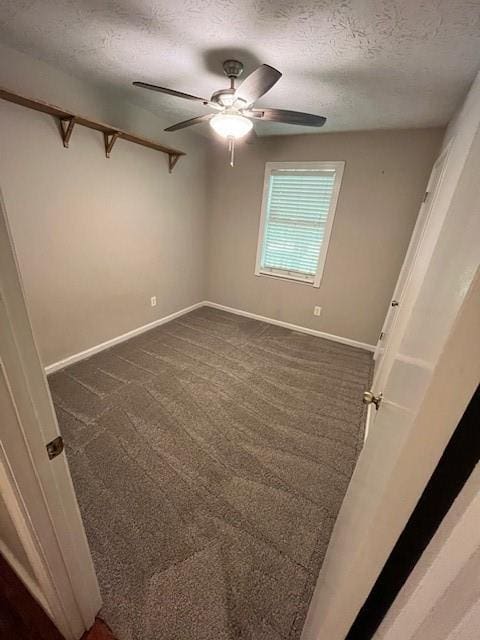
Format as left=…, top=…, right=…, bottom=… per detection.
left=45, top=300, right=375, bottom=376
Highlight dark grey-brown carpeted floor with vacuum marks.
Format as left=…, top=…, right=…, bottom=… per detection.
left=49, top=307, right=372, bottom=640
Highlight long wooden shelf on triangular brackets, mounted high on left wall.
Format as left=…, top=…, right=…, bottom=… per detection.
left=0, top=88, right=186, bottom=173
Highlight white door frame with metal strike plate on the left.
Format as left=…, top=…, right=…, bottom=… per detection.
left=0, top=195, right=101, bottom=640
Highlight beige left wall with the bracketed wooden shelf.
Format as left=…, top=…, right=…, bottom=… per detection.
left=0, top=47, right=207, bottom=365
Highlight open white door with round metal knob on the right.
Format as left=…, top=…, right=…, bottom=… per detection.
left=302, top=76, right=480, bottom=640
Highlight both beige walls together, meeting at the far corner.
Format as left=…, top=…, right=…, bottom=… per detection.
left=0, top=40, right=442, bottom=365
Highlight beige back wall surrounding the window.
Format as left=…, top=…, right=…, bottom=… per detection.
left=207, top=129, right=443, bottom=344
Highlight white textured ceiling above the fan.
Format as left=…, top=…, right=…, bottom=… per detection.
left=0, top=0, right=480, bottom=137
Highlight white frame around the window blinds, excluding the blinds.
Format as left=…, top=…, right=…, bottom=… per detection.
left=255, top=161, right=345, bottom=288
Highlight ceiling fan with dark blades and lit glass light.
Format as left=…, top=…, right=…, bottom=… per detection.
left=133, top=60, right=326, bottom=166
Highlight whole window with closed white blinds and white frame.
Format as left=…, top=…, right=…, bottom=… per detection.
left=255, top=162, right=345, bottom=287
